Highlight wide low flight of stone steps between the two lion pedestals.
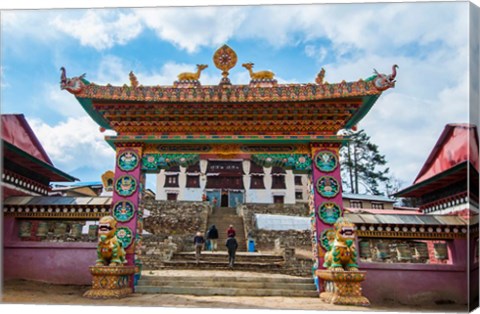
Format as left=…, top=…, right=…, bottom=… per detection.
left=135, top=270, right=318, bottom=298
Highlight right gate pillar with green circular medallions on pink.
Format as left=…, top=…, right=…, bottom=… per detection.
left=312, top=143, right=343, bottom=269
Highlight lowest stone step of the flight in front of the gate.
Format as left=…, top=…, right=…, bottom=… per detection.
left=135, top=286, right=318, bottom=298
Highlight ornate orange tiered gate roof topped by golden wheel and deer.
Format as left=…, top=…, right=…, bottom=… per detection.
left=61, top=45, right=397, bottom=143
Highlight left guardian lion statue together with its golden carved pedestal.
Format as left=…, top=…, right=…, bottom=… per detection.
left=83, top=216, right=137, bottom=299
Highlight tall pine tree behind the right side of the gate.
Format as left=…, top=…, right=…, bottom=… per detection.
left=340, top=130, right=393, bottom=195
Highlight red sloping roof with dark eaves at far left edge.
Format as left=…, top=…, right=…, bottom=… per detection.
left=1, top=114, right=78, bottom=181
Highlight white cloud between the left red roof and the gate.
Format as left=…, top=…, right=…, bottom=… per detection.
left=27, top=116, right=115, bottom=177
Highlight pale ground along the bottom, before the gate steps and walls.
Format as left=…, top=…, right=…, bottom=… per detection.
left=0, top=270, right=464, bottom=313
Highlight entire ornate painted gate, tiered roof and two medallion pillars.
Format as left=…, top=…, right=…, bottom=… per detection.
left=61, top=45, right=395, bottom=290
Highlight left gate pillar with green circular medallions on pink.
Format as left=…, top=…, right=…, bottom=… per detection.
left=111, top=143, right=145, bottom=266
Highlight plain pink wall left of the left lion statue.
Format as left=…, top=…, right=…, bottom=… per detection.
left=3, top=217, right=97, bottom=285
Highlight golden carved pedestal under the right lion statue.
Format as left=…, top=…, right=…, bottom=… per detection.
left=316, top=270, right=370, bottom=306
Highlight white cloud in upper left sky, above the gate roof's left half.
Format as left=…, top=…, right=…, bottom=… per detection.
left=51, top=10, right=142, bottom=50
